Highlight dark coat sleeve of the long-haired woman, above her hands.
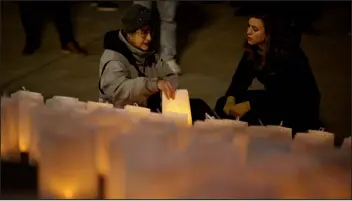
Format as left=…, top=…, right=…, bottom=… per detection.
left=226, top=54, right=255, bottom=99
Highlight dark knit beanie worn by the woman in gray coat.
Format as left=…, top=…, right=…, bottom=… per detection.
left=121, top=4, right=151, bottom=33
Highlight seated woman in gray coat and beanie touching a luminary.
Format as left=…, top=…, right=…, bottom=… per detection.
left=99, top=4, right=212, bottom=121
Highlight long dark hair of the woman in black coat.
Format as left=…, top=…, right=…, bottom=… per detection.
left=244, top=14, right=301, bottom=68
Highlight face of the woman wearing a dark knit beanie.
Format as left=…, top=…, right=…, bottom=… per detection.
left=128, top=26, right=152, bottom=51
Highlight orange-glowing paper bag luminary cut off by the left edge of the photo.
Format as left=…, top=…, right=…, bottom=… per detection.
left=1, top=97, right=20, bottom=161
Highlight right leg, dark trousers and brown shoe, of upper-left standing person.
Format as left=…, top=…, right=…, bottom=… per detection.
left=50, top=2, right=87, bottom=55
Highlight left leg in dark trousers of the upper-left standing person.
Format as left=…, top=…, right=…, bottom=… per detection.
left=18, top=1, right=43, bottom=55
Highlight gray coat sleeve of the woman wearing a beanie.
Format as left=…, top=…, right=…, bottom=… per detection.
left=100, top=61, right=158, bottom=106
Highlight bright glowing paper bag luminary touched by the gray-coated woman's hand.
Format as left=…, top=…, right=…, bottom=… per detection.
left=162, top=89, right=192, bottom=126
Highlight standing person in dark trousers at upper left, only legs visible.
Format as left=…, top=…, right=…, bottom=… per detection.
left=19, top=1, right=87, bottom=55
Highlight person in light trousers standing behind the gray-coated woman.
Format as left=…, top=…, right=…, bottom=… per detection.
left=134, top=0, right=181, bottom=74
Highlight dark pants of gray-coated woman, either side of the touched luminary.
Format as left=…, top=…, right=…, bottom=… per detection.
left=147, top=93, right=214, bottom=122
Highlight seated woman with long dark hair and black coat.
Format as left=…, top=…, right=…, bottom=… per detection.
left=215, top=15, right=320, bottom=133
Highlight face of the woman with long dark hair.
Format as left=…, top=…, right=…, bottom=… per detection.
left=247, top=17, right=266, bottom=45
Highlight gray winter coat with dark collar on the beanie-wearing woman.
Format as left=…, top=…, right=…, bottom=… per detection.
left=99, top=30, right=178, bottom=108
